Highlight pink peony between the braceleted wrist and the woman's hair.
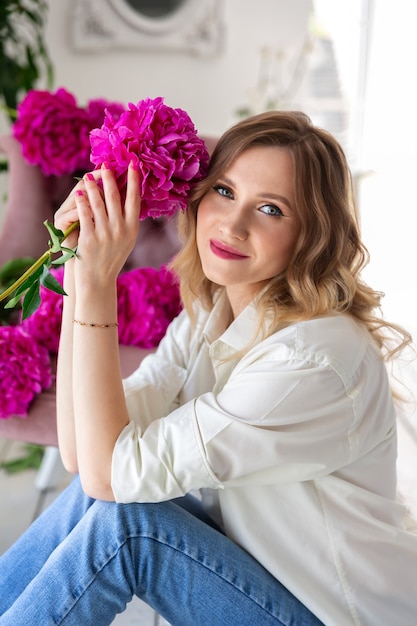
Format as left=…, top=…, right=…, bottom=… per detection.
left=117, top=267, right=181, bottom=348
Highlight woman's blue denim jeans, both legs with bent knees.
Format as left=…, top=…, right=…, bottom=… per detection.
left=0, top=478, right=321, bottom=626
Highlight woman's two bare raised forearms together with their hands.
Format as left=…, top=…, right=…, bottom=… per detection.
left=55, top=167, right=140, bottom=500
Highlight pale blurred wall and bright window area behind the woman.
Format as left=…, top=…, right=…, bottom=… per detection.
left=0, top=0, right=417, bottom=330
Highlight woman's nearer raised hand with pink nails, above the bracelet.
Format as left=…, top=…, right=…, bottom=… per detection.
left=72, top=161, right=140, bottom=288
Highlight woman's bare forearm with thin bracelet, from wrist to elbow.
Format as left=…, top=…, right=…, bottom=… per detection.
left=73, top=284, right=129, bottom=500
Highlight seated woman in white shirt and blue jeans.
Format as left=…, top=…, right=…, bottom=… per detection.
left=0, top=112, right=417, bottom=626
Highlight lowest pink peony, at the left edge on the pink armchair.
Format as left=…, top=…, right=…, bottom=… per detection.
left=0, top=326, right=52, bottom=419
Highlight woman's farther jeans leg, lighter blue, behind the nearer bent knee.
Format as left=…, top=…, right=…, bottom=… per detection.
left=0, top=477, right=94, bottom=615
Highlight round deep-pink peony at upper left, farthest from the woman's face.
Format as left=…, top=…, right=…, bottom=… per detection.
left=13, top=89, right=91, bottom=176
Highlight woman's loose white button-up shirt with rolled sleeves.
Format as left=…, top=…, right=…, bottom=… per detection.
left=112, top=298, right=417, bottom=626
